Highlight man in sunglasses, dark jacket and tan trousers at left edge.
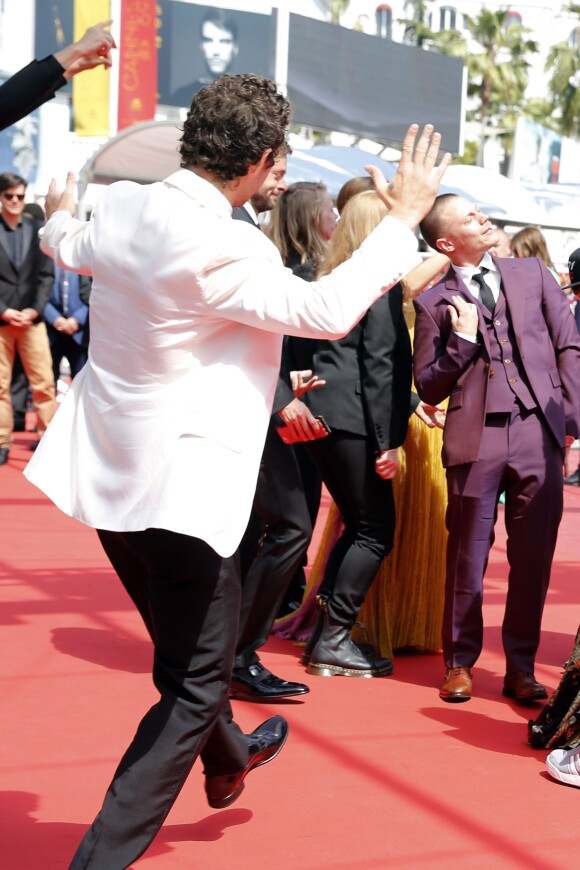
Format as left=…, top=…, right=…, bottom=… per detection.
left=0, top=172, right=56, bottom=465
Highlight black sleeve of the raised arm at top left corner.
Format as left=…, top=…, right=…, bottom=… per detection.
left=0, top=55, right=66, bottom=130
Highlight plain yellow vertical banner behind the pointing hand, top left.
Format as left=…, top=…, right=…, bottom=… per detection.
left=73, top=0, right=111, bottom=136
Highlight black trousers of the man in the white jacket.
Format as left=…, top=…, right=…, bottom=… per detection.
left=70, top=529, right=248, bottom=870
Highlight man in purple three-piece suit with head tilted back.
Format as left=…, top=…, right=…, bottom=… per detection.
left=414, top=194, right=580, bottom=703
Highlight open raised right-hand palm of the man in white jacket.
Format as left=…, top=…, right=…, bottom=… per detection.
left=365, top=124, right=451, bottom=229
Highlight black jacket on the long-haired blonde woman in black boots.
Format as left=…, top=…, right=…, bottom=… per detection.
left=290, top=284, right=411, bottom=450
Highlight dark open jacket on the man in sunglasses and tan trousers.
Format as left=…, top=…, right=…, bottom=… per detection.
left=0, top=215, right=54, bottom=327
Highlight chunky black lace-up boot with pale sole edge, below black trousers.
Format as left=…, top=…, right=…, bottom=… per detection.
left=306, top=612, right=393, bottom=677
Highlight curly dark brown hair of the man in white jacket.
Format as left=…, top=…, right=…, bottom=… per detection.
left=180, top=73, right=290, bottom=181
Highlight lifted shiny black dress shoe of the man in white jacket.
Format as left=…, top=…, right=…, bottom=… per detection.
left=205, top=716, right=288, bottom=810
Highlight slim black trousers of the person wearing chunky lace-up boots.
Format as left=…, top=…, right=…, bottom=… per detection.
left=308, top=429, right=396, bottom=625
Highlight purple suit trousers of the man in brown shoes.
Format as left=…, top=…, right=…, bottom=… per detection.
left=443, top=406, right=563, bottom=672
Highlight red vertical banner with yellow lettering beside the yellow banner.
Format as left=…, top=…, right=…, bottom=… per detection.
left=118, top=0, right=157, bottom=130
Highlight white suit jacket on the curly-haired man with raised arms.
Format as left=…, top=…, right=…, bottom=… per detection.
left=24, top=169, right=419, bottom=556
